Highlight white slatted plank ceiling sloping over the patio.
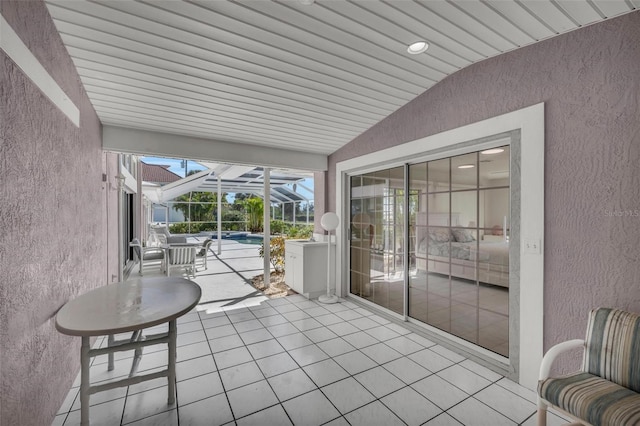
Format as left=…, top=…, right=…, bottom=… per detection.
left=47, top=0, right=640, bottom=154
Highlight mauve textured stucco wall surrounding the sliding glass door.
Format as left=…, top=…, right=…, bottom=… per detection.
left=327, top=12, right=640, bottom=369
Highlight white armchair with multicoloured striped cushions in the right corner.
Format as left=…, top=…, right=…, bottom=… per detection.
left=538, top=308, right=640, bottom=426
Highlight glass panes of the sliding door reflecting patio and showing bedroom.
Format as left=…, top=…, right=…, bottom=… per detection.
left=350, top=146, right=510, bottom=356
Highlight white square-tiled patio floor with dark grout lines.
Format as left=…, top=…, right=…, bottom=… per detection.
left=53, top=241, right=563, bottom=426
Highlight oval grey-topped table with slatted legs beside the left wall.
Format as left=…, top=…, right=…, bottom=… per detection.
left=56, top=277, right=202, bottom=425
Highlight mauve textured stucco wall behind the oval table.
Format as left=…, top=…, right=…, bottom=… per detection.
left=0, top=0, right=117, bottom=426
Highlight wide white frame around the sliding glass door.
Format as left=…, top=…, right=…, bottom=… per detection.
left=335, top=103, right=544, bottom=389
